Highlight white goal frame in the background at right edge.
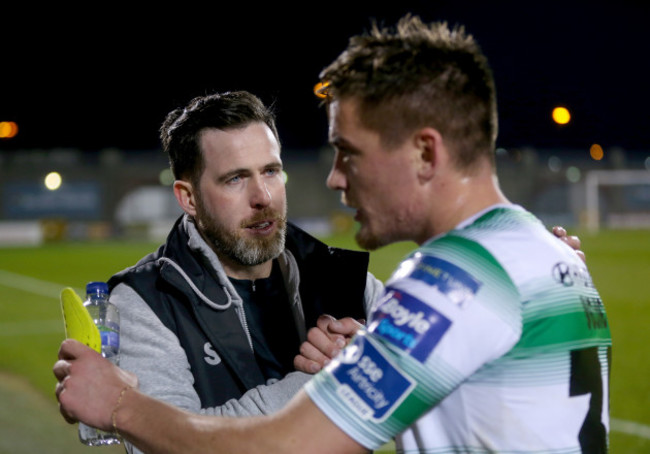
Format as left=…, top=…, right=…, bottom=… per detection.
left=585, top=170, right=650, bottom=232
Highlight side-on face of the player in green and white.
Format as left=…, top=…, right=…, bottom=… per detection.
left=327, top=99, right=417, bottom=250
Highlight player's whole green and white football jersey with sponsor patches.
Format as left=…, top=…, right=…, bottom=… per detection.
left=305, top=205, right=611, bottom=454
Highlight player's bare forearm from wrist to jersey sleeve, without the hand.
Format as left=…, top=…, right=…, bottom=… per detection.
left=116, top=384, right=367, bottom=454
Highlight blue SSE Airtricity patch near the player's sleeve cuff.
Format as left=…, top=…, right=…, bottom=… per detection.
left=327, top=332, right=415, bottom=422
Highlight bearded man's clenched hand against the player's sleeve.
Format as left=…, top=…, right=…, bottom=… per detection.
left=293, top=315, right=362, bottom=374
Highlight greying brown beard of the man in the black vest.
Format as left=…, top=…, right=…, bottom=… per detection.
left=195, top=196, right=287, bottom=266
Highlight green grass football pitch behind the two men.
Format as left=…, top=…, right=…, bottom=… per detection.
left=0, top=231, right=650, bottom=454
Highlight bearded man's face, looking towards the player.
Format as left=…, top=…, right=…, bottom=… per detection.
left=190, top=123, right=287, bottom=266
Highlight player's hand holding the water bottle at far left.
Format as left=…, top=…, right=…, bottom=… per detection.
left=53, top=339, right=138, bottom=431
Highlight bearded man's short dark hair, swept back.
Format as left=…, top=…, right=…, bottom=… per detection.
left=160, top=91, right=280, bottom=183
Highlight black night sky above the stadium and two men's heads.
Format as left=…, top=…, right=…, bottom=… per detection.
left=0, top=0, right=650, bottom=151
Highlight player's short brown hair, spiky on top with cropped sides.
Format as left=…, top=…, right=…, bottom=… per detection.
left=320, top=15, right=498, bottom=168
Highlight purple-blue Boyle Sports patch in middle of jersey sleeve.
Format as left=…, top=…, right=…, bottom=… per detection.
left=368, top=287, right=451, bottom=362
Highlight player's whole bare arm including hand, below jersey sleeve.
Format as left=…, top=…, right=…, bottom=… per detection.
left=54, top=340, right=367, bottom=454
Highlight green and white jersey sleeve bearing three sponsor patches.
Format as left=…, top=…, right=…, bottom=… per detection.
left=305, top=237, right=522, bottom=449
